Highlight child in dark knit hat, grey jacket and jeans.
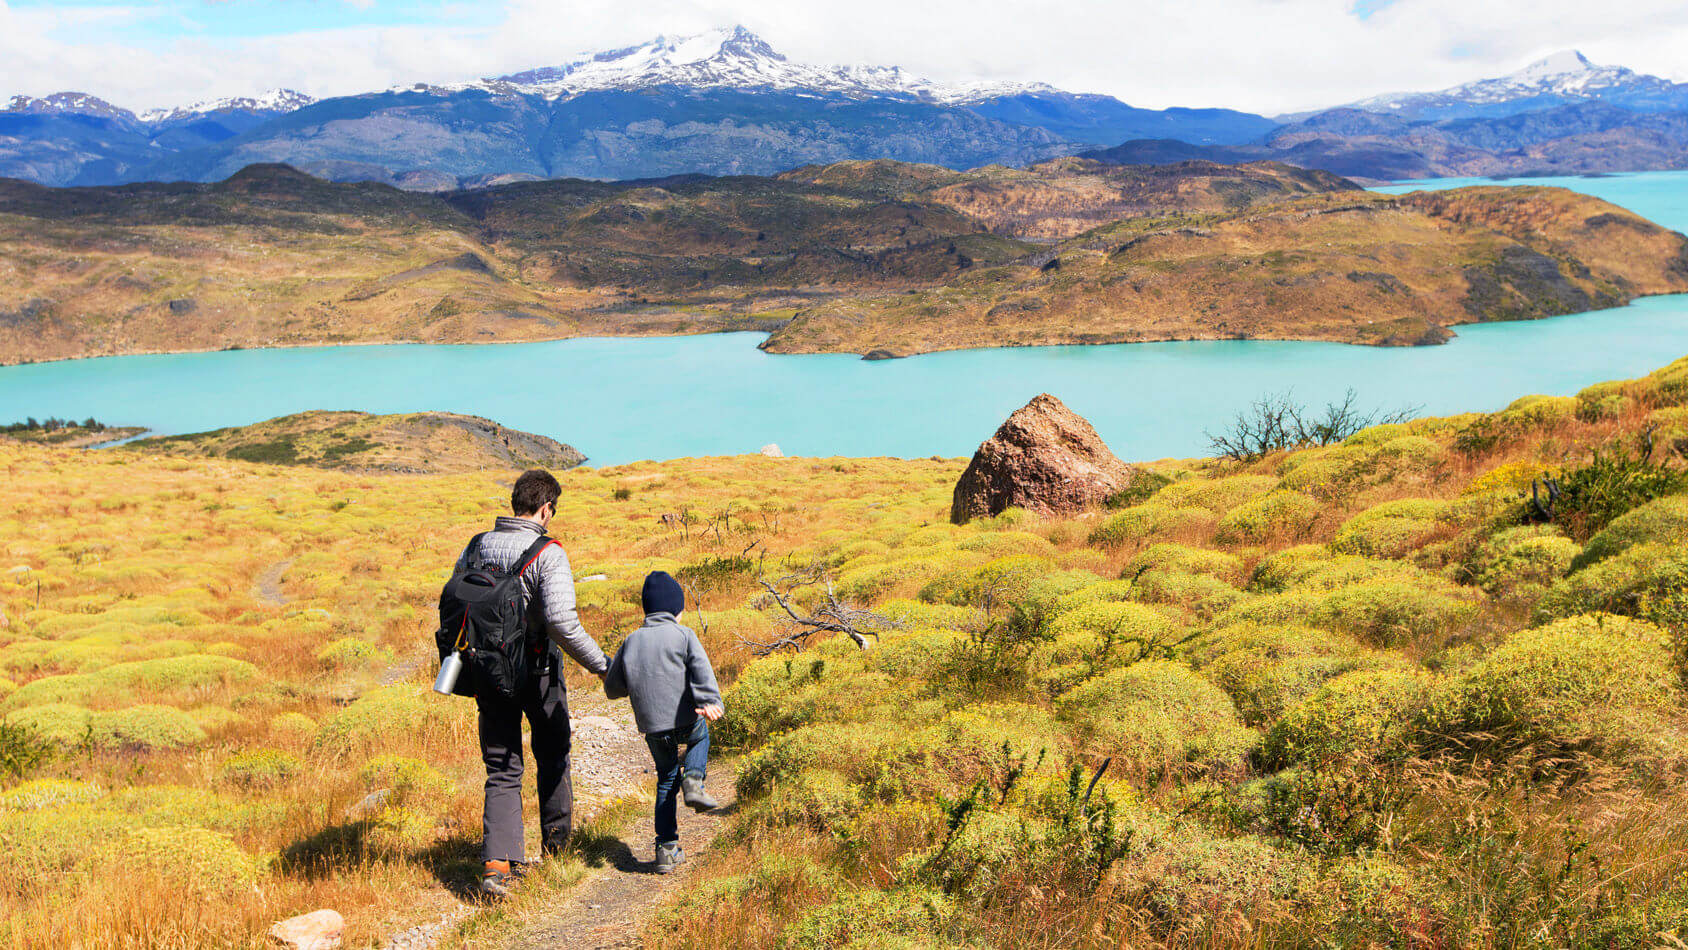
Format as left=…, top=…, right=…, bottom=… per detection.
left=604, top=570, right=724, bottom=874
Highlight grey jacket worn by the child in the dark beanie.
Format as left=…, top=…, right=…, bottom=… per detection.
left=604, top=613, right=722, bottom=734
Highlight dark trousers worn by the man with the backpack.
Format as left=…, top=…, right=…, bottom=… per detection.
left=474, top=658, right=574, bottom=861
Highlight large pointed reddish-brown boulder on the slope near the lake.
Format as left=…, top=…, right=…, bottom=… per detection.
left=950, top=393, right=1136, bottom=525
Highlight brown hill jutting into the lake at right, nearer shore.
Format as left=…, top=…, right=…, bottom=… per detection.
left=763, top=187, right=1688, bottom=356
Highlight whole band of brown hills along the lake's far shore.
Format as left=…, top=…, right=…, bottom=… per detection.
left=0, top=159, right=1685, bottom=363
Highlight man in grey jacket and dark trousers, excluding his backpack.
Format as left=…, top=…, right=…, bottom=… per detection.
left=452, top=469, right=609, bottom=898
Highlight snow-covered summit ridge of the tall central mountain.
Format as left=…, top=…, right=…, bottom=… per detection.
left=419, top=27, right=1058, bottom=103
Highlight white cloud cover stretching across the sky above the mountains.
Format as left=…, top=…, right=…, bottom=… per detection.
left=0, top=0, right=1688, bottom=113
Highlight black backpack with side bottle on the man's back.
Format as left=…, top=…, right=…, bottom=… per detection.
left=434, top=535, right=555, bottom=700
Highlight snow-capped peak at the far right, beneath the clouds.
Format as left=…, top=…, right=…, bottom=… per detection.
left=1345, top=49, right=1688, bottom=120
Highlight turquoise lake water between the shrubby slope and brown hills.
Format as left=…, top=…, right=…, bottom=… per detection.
left=0, top=172, right=1688, bottom=464
